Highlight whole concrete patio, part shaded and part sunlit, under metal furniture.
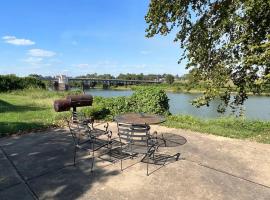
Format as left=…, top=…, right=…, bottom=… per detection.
left=0, top=123, right=270, bottom=200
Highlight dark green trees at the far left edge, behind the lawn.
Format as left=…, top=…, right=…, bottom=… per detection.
left=0, top=75, right=46, bottom=92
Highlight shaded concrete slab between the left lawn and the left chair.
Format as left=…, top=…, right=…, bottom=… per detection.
left=0, top=130, right=73, bottom=180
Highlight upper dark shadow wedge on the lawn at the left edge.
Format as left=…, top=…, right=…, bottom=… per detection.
left=0, top=99, right=46, bottom=113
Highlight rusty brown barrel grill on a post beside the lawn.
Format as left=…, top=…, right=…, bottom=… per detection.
left=54, top=94, right=93, bottom=121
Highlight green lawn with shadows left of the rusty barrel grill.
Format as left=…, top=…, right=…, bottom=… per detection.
left=0, top=89, right=80, bottom=136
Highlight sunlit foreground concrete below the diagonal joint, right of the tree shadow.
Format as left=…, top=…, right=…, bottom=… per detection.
left=80, top=160, right=270, bottom=200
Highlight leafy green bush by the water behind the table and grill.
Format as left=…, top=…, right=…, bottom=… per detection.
left=82, top=88, right=170, bottom=119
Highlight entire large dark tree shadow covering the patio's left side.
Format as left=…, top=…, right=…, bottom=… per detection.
left=0, top=130, right=119, bottom=199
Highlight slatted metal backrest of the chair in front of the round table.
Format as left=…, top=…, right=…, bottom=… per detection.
left=117, top=123, right=150, bottom=145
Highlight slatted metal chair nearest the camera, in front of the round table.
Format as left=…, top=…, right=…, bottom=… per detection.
left=117, top=123, right=158, bottom=176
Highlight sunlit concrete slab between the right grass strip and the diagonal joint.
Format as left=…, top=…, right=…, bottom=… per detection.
left=149, top=126, right=270, bottom=187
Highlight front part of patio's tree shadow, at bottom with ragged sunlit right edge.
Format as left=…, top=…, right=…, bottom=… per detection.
left=29, top=159, right=119, bottom=199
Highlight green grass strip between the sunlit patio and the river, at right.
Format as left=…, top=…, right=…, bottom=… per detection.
left=164, top=115, right=270, bottom=144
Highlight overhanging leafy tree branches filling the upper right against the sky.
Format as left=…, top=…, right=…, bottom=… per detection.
left=145, top=0, right=270, bottom=111
